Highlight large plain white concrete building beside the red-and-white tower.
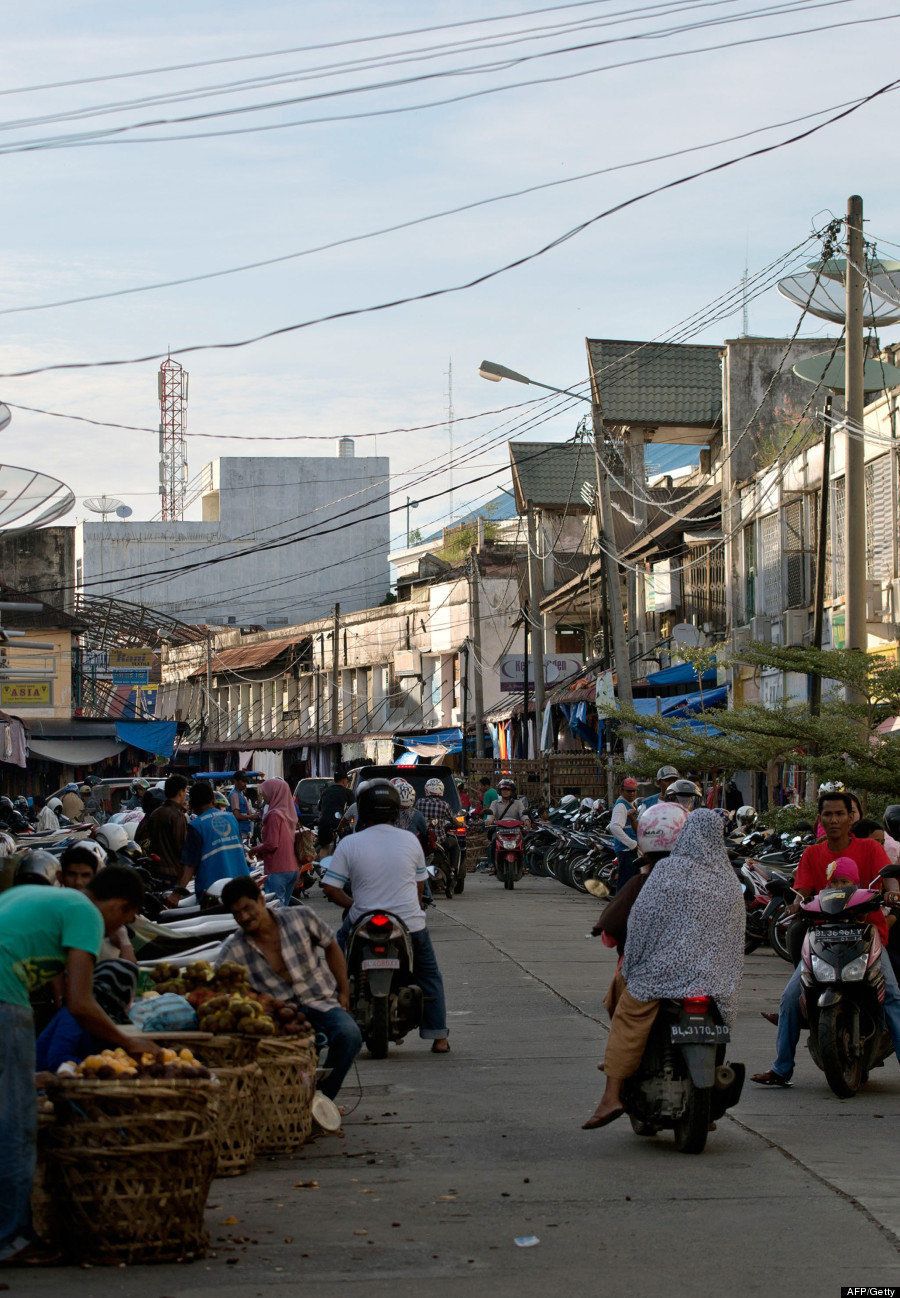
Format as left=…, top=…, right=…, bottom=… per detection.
left=75, top=449, right=390, bottom=627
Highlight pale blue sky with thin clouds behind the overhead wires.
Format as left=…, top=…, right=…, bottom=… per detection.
left=0, top=0, right=900, bottom=552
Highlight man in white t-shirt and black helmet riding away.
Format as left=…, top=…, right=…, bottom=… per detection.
left=322, top=780, right=449, bottom=1054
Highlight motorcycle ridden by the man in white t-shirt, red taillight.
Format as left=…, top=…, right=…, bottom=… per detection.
left=347, top=910, right=425, bottom=1059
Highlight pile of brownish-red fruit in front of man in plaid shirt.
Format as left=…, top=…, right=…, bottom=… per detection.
left=151, top=961, right=310, bottom=1037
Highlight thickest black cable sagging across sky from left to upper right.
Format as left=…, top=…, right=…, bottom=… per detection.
left=0, top=78, right=900, bottom=379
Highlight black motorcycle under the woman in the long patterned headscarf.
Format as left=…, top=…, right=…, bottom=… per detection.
left=622, top=996, right=745, bottom=1154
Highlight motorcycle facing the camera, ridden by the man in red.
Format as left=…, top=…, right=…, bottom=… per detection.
left=800, top=866, right=900, bottom=1099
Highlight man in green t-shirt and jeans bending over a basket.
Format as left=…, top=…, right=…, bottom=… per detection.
left=0, top=851, right=158, bottom=1264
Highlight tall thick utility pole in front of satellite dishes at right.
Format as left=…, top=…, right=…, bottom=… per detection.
left=844, top=193, right=868, bottom=702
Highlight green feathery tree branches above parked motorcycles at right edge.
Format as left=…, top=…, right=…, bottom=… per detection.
left=617, top=644, right=900, bottom=796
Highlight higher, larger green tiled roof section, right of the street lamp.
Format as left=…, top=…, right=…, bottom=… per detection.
left=587, top=337, right=722, bottom=428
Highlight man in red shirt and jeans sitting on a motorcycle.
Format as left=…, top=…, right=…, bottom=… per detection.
left=751, top=793, right=900, bottom=1086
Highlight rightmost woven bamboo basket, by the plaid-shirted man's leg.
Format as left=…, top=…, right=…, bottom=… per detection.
left=256, top=1033, right=317, bottom=1154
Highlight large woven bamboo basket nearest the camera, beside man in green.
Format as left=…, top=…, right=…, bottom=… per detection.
left=48, top=1079, right=219, bottom=1264
